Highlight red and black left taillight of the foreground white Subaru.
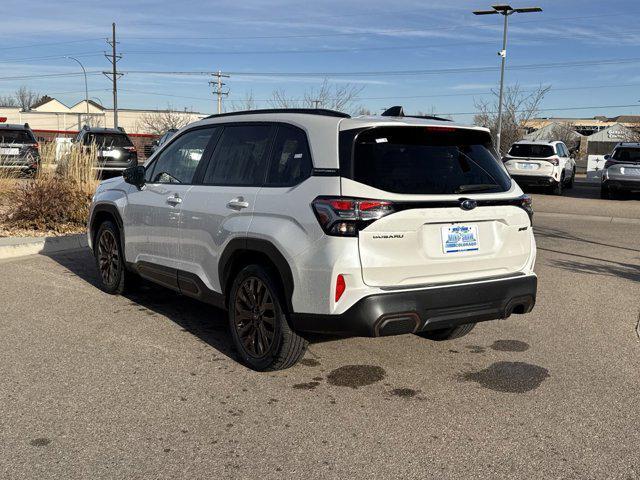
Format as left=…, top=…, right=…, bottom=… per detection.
left=311, top=197, right=395, bottom=237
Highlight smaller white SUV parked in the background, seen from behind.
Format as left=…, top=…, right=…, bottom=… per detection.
left=502, top=140, right=576, bottom=195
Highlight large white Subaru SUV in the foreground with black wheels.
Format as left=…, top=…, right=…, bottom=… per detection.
left=89, top=109, right=537, bottom=370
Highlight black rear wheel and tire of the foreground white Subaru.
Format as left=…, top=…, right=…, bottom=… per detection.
left=228, top=265, right=308, bottom=372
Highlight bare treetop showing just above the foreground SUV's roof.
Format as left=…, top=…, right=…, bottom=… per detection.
left=269, top=78, right=364, bottom=111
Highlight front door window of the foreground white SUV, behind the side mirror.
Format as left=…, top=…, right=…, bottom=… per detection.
left=147, top=127, right=217, bottom=183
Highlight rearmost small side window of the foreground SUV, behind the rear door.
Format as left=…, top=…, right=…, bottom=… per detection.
left=266, top=125, right=312, bottom=187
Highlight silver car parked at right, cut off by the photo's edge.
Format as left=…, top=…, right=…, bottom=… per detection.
left=600, top=142, right=640, bottom=198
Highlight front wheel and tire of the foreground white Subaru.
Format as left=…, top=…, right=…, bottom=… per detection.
left=93, top=221, right=138, bottom=295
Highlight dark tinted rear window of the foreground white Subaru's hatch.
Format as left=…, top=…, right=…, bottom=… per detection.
left=341, top=127, right=511, bottom=195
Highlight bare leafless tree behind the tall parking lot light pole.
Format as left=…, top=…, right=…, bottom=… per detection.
left=473, top=84, right=551, bottom=152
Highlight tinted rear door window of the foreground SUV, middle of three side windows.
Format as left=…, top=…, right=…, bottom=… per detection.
left=203, top=125, right=273, bottom=186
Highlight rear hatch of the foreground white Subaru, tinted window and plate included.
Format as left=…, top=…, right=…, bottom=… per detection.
left=341, top=127, right=532, bottom=288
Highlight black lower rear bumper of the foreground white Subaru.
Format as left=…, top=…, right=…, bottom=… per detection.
left=291, top=275, right=537, bottom=337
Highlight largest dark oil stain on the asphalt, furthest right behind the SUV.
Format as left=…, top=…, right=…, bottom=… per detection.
left=461, top=362, right=549, bottom=393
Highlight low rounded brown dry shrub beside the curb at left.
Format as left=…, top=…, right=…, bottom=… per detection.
left=9, top=176, right=92, bottom=232
